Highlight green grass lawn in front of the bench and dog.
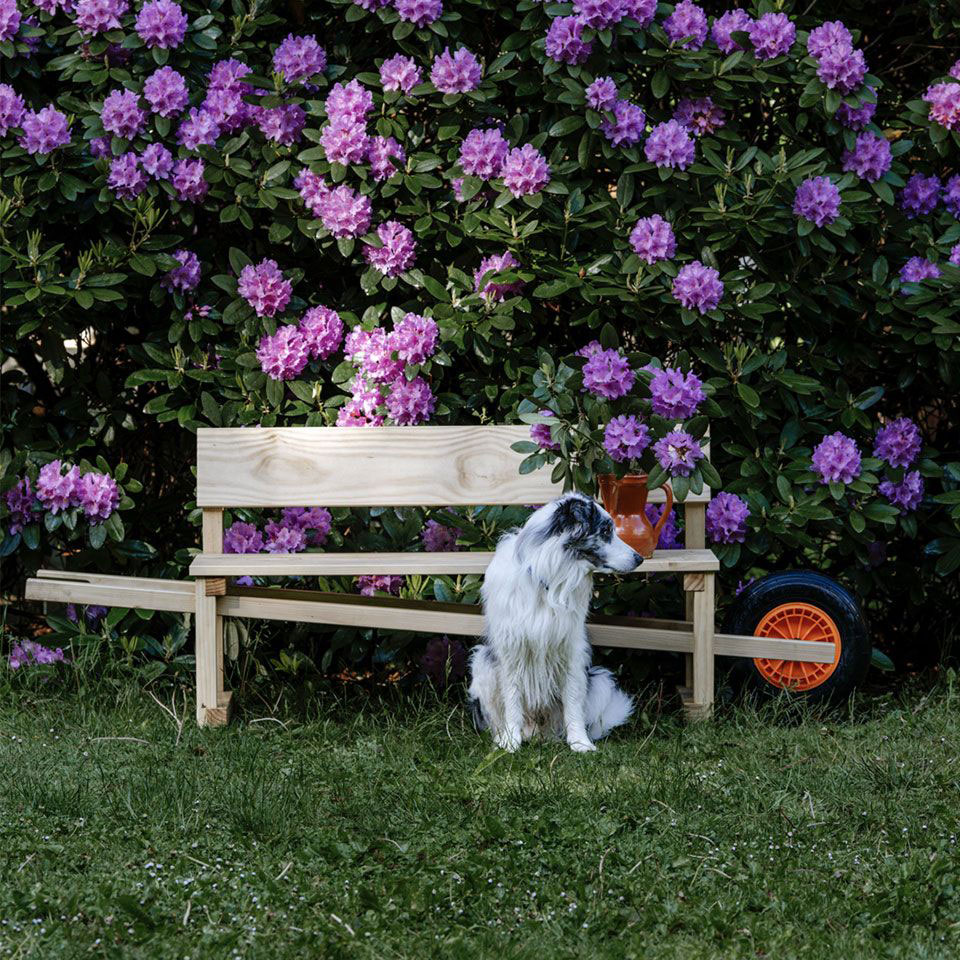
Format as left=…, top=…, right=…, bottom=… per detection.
left=0, top=674, right=960, bottom=960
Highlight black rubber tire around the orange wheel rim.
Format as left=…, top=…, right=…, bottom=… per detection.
left=723, top=570, right=872, bottom=705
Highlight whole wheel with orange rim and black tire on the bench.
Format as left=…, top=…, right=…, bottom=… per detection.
left=723, top=570, right=872, bottom=703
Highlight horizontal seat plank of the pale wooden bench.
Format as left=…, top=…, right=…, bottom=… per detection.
left=190, top=550, right=719, bottom=577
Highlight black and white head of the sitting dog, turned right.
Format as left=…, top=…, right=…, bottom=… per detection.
left=520, top=493, right=643, bottom=573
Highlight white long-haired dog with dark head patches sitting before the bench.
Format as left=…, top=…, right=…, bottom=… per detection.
left=469, top=493, right=643, bottom=753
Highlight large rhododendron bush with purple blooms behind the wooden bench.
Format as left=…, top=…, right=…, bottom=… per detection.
left=0, top=0, right=960, bottom=664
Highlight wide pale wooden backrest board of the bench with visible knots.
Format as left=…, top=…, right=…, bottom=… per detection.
left=197, top=424, right=710, bottom=507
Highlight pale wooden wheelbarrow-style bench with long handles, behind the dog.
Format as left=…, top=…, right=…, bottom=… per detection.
left=20, top=425, right=833, bottom=725
